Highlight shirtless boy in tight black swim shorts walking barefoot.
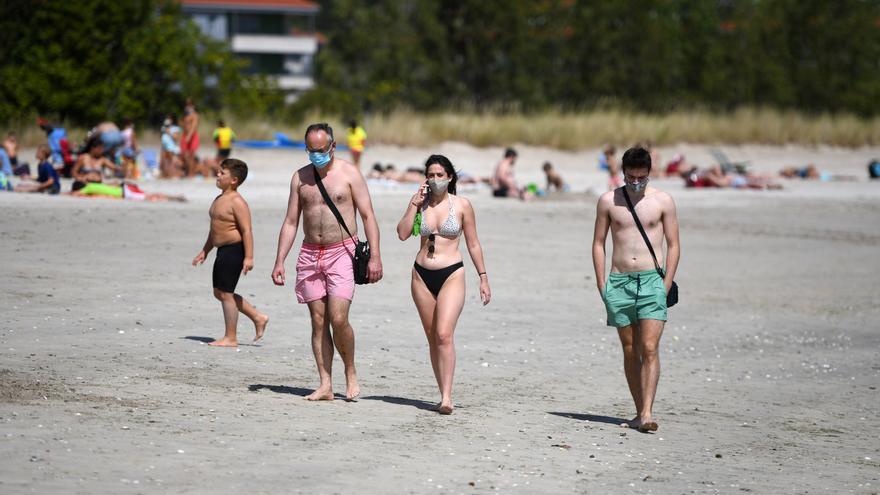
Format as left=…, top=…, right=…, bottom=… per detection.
left=193, top=158, right=269, bottom=347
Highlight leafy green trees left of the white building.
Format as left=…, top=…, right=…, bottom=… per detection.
left=0, top=0, right=280, bottom=126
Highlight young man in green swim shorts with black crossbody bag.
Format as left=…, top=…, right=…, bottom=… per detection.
left=593, top=148, right=680, bottom=431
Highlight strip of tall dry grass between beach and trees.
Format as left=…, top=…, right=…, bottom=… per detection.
left=7, top=108, right=880, bottom=150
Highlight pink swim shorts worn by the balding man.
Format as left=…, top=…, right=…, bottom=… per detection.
left=295, top=237, right=358, bottom=304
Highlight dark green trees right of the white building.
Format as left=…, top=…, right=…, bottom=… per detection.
left=314, top=0, right=880, bottom=116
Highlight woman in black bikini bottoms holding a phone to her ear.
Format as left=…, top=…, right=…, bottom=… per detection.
left=397, top=155, right=492, bottom=414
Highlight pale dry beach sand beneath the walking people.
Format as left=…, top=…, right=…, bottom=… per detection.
left=0, top=143, right=880, bottom=494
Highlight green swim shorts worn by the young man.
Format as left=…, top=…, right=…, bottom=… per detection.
left=602, top=270, right=666, bottom=328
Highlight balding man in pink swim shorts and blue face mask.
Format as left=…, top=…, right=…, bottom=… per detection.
left=272, top=124, right=382, bottom=400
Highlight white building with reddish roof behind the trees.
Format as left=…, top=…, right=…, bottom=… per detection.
left=181, top=0, right=320, bottom=100
